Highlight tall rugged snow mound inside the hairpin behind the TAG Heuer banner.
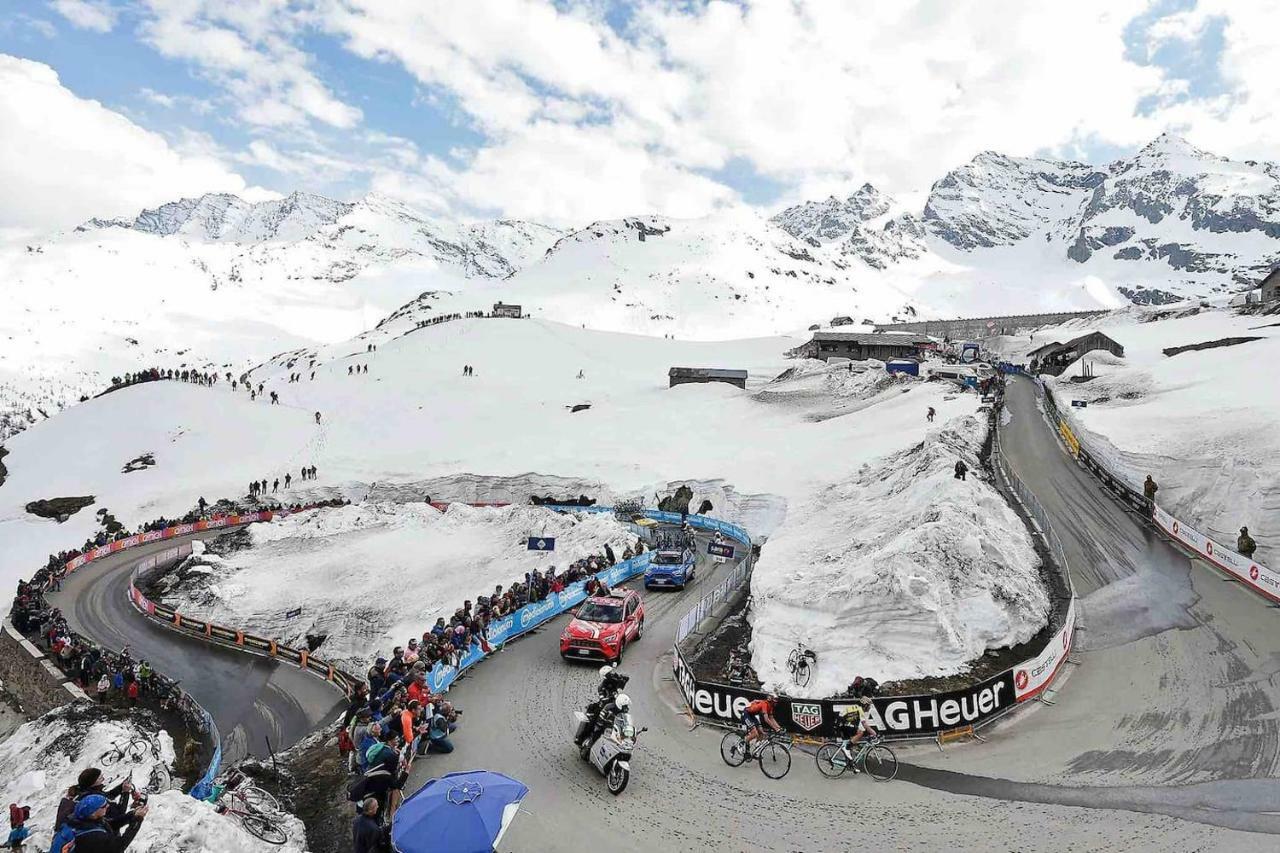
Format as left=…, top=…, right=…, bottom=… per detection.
left=751, top=416, right=1050, bottom=695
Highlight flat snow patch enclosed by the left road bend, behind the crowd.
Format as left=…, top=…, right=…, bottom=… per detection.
left=165, top=503, right=636, bottom=663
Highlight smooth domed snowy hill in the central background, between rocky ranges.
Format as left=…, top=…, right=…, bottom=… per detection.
left=465, top=214, right=909, bottom=339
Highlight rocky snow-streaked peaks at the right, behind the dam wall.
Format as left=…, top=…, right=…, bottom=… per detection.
left=773, top=133, right=1280, bottom=306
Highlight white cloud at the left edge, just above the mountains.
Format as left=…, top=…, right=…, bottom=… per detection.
left=0, top=54, right=257, bottom=228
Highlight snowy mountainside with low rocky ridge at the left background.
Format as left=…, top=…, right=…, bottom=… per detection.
left=0, top=193, right=561, bottom=441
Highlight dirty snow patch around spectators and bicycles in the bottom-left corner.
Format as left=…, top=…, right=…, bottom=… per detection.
left=0, top=704, right=306, bottom=853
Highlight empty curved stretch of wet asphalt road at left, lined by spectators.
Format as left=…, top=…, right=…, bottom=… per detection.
left=50, top=534, right=346, bottom=762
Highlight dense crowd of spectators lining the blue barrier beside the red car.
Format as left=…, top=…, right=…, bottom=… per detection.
left=338, top=525, right=645, bottom=829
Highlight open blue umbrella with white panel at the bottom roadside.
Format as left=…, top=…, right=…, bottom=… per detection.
left=392, top=770, right=529, bottom=853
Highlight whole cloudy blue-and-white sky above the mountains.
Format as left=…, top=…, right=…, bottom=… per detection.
left=0, top=0, right=1280, bottom=228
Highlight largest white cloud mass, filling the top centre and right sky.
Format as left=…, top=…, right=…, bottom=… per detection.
left=321, top=0, right=1162, bottom=218
